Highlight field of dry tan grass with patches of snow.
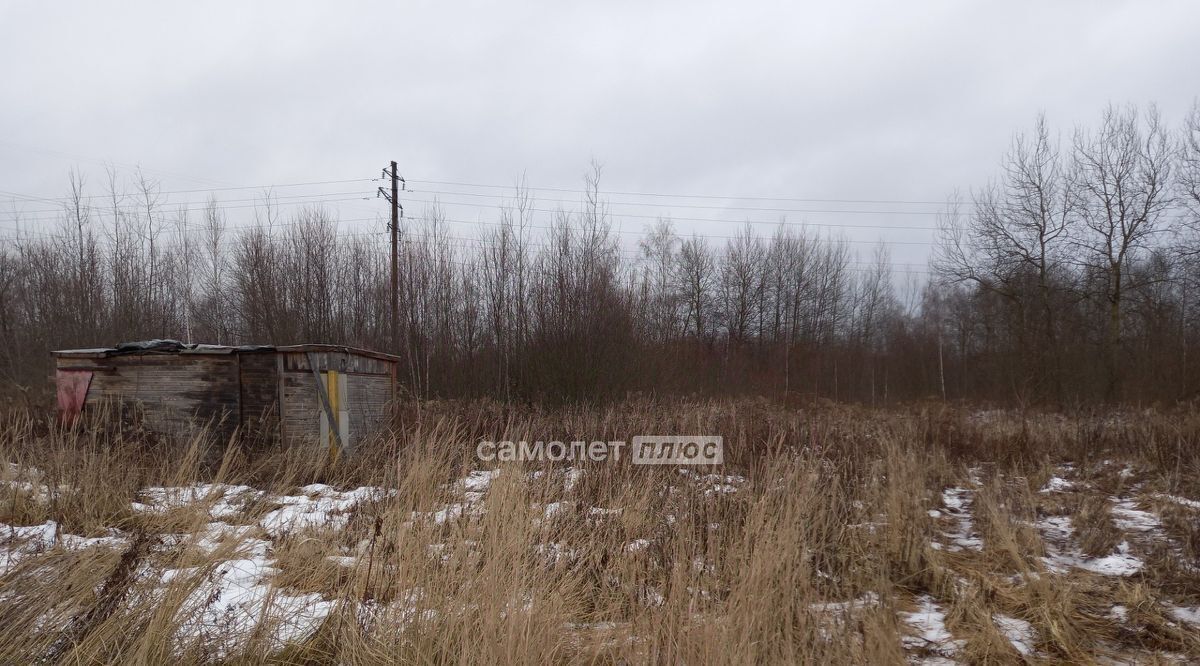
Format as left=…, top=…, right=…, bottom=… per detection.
left=0, top=400, right=1200, bottom=664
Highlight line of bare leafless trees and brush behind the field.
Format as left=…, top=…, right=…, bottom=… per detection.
left=7, top=107, right=1200, bottom=406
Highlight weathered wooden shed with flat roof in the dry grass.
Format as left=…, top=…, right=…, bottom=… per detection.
left=53, top=340, right=400, bottom=449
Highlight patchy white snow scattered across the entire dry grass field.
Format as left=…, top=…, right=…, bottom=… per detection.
left=0, top=460, right=1200, bottom=664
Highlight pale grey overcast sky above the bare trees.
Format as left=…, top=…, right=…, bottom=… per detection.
left=0, top=0, right=1200, bottom=271
